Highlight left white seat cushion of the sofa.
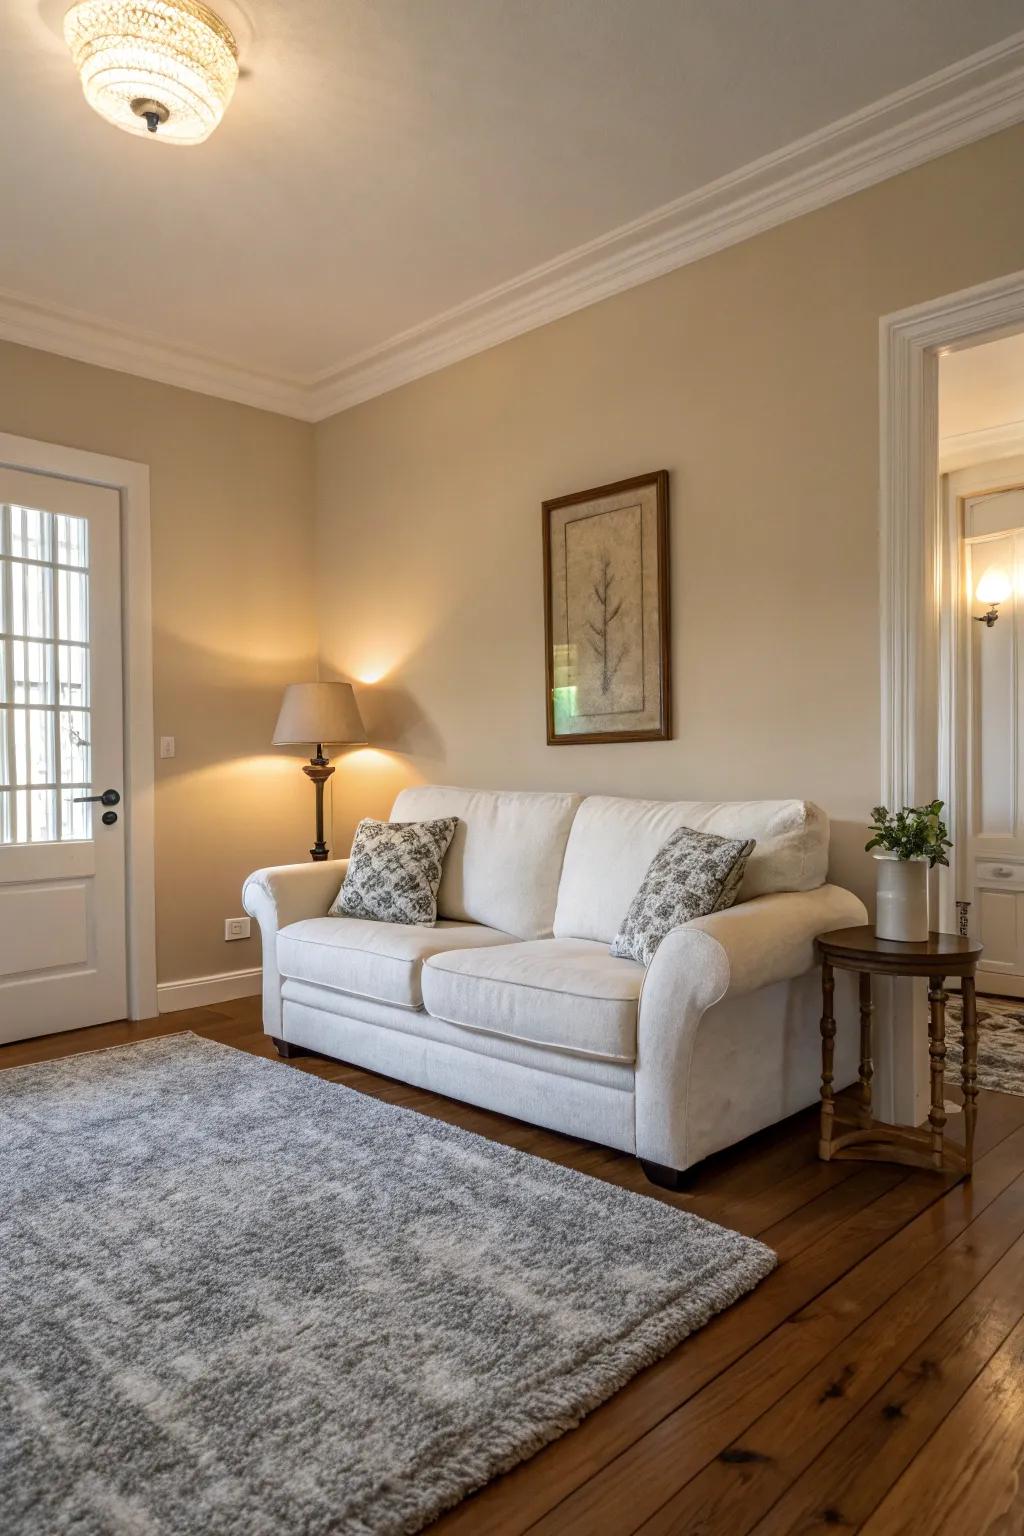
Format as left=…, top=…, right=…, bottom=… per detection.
left=278, top=917, right=514, bottom=1008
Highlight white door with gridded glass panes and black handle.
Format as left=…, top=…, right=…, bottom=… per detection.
left=0, top=468, right=127, bottom=1041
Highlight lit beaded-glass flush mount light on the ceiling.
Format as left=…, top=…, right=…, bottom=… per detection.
left=64, top=0, right=238, bottom=144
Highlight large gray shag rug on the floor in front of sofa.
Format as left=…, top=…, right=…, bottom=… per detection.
left=0, top=1034, right=775, bottom=1536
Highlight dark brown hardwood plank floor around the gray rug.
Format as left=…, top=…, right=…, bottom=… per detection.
left=0, top=998, right=1024, bottom=1536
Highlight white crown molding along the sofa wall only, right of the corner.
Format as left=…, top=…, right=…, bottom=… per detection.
left=313, top=32, right=1024, bottom=421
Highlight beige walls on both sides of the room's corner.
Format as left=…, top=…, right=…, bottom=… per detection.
left=0, top=129, right=1024, bottom=980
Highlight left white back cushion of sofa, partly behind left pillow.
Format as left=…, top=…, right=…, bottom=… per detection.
left=391, top=785, right=580, bottom=938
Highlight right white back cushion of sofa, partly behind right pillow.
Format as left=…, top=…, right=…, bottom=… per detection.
left=552, top=794, right=829, bottom=943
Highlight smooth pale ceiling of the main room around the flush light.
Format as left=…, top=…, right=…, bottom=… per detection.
left=0, top=0, right=1024, bottom=413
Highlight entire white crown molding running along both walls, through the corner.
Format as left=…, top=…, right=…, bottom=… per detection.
left=0, top=32, right=1024, bottom=421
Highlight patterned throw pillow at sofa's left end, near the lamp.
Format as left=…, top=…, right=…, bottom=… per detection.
left=330, top=816, right=459, bottom=928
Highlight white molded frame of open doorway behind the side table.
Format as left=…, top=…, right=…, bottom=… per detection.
left=878, top=272, right=1024, bottom=1124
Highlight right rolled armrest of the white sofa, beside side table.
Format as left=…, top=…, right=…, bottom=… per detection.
left=636, top=885, right=867, bottom=1169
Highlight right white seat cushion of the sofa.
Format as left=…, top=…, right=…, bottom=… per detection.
left=422, top=938, right=643, bottom=1063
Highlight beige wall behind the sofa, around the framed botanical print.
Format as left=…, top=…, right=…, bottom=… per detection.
left=316, top=129, right=1024, bottom=909
